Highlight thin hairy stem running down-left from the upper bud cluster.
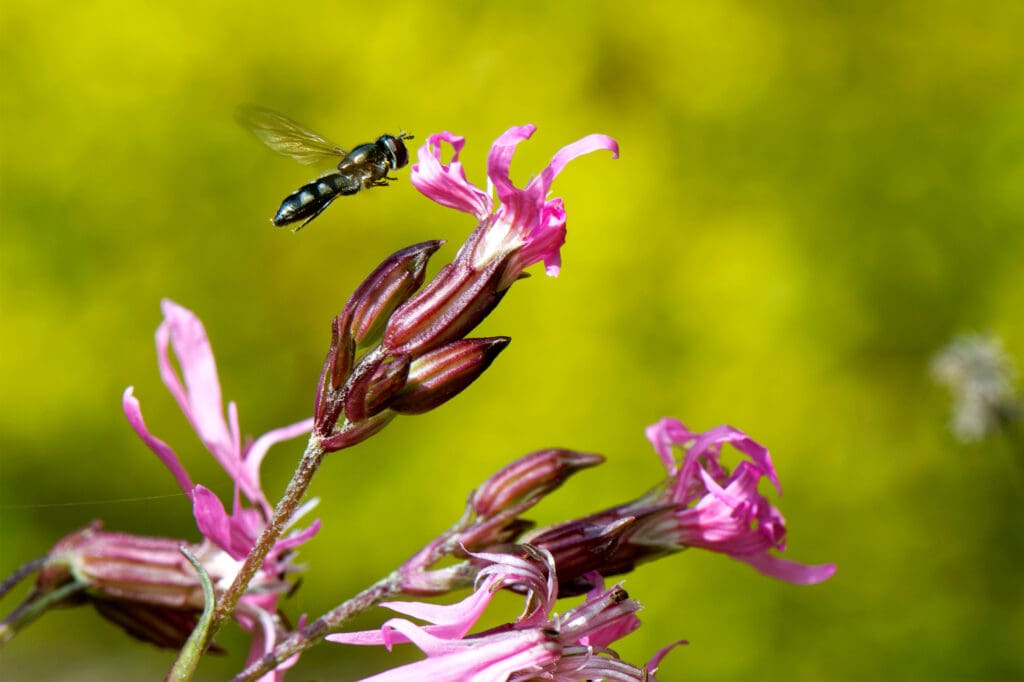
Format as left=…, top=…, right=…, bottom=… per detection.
left=203, top=434, right=326, bottom=650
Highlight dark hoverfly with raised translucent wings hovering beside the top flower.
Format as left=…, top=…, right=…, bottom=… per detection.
left=238, top=105, right=413, bottom=230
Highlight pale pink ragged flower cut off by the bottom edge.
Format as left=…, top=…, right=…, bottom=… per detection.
left=327, top=552, right=668, bottom=682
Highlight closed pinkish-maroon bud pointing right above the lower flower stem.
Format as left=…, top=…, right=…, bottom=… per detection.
left=470, top=447, right=604, bottom=518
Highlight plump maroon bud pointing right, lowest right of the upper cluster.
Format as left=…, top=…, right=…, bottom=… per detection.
left=387, top=336, right=511, bottom=415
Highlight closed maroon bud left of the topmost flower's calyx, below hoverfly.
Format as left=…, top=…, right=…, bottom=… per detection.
left=345, top=240, right=444, bottom=344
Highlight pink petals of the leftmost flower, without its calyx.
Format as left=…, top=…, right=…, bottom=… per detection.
left=122, top=299, right=319, bottom=659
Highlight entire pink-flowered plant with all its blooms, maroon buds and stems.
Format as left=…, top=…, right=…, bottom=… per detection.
left=0, top=125, right=836, bottom=682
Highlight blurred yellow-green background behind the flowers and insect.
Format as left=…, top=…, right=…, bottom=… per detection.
left=0, top=0, right=1024, bottom=681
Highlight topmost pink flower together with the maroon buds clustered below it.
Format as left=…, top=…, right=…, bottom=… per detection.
left=313, top=125, right=618, bottom=452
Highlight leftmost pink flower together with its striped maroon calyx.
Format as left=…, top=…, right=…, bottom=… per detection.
left=9, top=300, right=319, bottom=675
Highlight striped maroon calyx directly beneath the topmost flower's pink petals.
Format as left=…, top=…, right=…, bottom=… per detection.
left=383, top=253, right=507, bottom=354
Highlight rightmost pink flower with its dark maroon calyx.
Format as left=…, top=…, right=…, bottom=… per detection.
left=518, top=419, right=836, bottom=585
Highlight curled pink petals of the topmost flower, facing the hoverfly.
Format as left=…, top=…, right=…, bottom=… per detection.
left=410, top=124, right=618, bottom=290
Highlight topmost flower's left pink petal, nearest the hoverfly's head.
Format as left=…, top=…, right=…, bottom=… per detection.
left=410, top=131, right=493, bottom=220
